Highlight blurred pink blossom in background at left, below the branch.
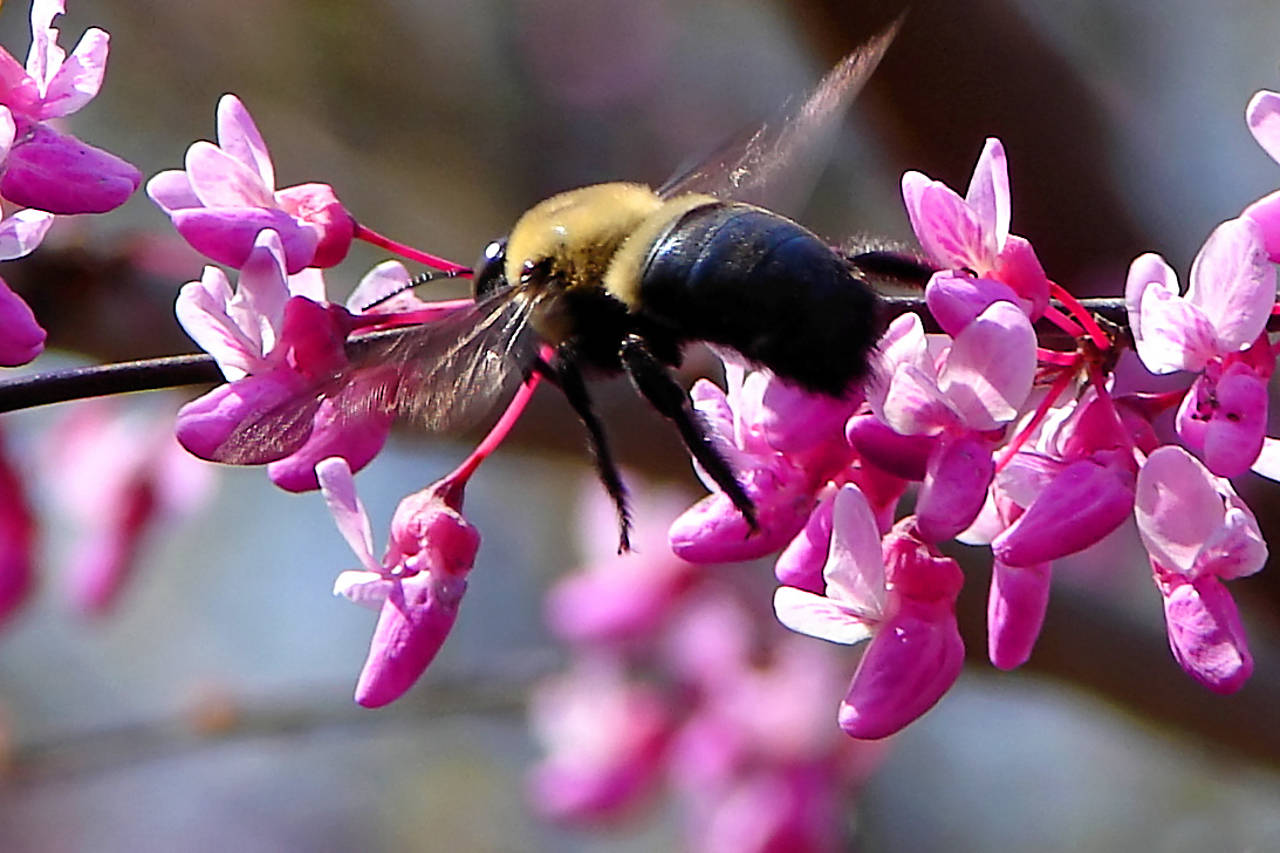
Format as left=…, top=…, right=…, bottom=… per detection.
left=44, top=400, right=212, bottom=616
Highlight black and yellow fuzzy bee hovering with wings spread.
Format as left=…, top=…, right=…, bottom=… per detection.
left=216, top=23, right=915, bottom=551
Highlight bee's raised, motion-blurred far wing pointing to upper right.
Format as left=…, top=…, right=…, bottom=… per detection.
left=658, top=18, right=902, bottom=201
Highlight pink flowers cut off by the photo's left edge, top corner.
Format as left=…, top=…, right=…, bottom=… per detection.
left=0, top=0, right=142, bottom=366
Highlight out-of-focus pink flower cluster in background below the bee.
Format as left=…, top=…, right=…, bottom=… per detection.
left=530, top=480, right=886, bottom=852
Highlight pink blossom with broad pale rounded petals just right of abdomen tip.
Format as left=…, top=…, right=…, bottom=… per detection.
left=851, top=301, right=1036, bottom=542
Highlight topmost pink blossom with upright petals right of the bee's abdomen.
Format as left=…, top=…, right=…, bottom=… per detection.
left=902, top=138, right=1050, bottom=324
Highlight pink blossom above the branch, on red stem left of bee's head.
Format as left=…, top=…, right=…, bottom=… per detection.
left=147, top=95, right=356, bottom=274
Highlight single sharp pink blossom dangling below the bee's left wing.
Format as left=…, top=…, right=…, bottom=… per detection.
left=316, top=456, right=480, bottom=708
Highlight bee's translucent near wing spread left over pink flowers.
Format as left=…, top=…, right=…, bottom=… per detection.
left=214, top=289, right=539, bottom=465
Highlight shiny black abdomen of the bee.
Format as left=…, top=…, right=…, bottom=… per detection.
left=640, top=202, right=876, bottom=396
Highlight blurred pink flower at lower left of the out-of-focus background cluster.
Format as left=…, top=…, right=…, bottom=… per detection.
left=529, top=656, right=672, bottom=821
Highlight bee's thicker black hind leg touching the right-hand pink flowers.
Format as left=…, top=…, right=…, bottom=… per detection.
left=618, top=334, right=760, bottom=532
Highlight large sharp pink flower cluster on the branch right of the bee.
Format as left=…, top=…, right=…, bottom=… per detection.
left=669, top=128, right=1280, bottom=738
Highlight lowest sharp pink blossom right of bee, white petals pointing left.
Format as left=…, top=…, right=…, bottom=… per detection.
left=773, top=485, right=964, bottom=738
